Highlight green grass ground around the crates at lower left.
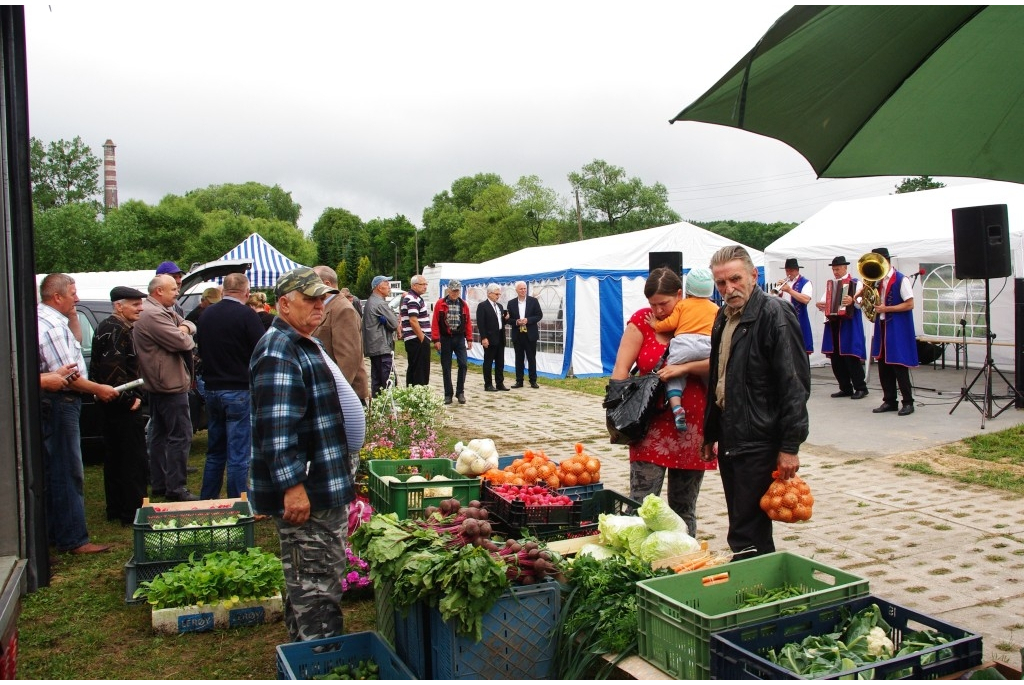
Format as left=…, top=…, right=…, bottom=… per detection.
left=17, top=432, right=375, bottom=680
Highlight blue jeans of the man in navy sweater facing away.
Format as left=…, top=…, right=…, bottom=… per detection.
left=200, top=388, right=252, bottom=500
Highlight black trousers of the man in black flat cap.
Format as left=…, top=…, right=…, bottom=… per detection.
left=100, top=404, right=150, bottom=525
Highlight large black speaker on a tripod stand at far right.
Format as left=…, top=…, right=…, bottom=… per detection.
left=953, top=205, right=1013, bottom=279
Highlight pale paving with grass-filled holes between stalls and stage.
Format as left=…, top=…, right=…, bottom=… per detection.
left=385, top=354, right=1024, bottom=669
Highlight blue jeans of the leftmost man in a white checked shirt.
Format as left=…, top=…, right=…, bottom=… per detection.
left=40, top=392, right=89, bottom=552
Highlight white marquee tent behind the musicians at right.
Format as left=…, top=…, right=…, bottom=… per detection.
left=765, top=181, right=1024, bottom=366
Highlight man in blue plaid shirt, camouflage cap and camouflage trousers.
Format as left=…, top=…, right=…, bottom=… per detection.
left=249, top=267, right=366, bottom=641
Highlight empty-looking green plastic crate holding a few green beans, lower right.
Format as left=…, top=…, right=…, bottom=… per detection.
left=637, top=552, right=868, bottom=680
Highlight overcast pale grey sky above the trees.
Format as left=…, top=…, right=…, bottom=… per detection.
left=26, top=0, right=959, bottom=230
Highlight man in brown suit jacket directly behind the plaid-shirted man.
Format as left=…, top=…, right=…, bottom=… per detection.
left=313, top=265, right=370, bottom=404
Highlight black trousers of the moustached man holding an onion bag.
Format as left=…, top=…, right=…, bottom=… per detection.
left=718, top=445, right=778, bottom=560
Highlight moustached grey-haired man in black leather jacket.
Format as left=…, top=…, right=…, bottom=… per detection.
left=703, top=246, right=811, bottom=559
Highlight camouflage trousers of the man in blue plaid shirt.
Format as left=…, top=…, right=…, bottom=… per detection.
left=273, top=507, right=348, bottom=642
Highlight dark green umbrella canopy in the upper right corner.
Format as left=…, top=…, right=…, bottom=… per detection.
left=672, top=5, right=1024, bottom=182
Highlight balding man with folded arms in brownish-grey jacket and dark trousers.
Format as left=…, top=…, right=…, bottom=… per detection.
left=135, top=274, right=199, bottom=502
